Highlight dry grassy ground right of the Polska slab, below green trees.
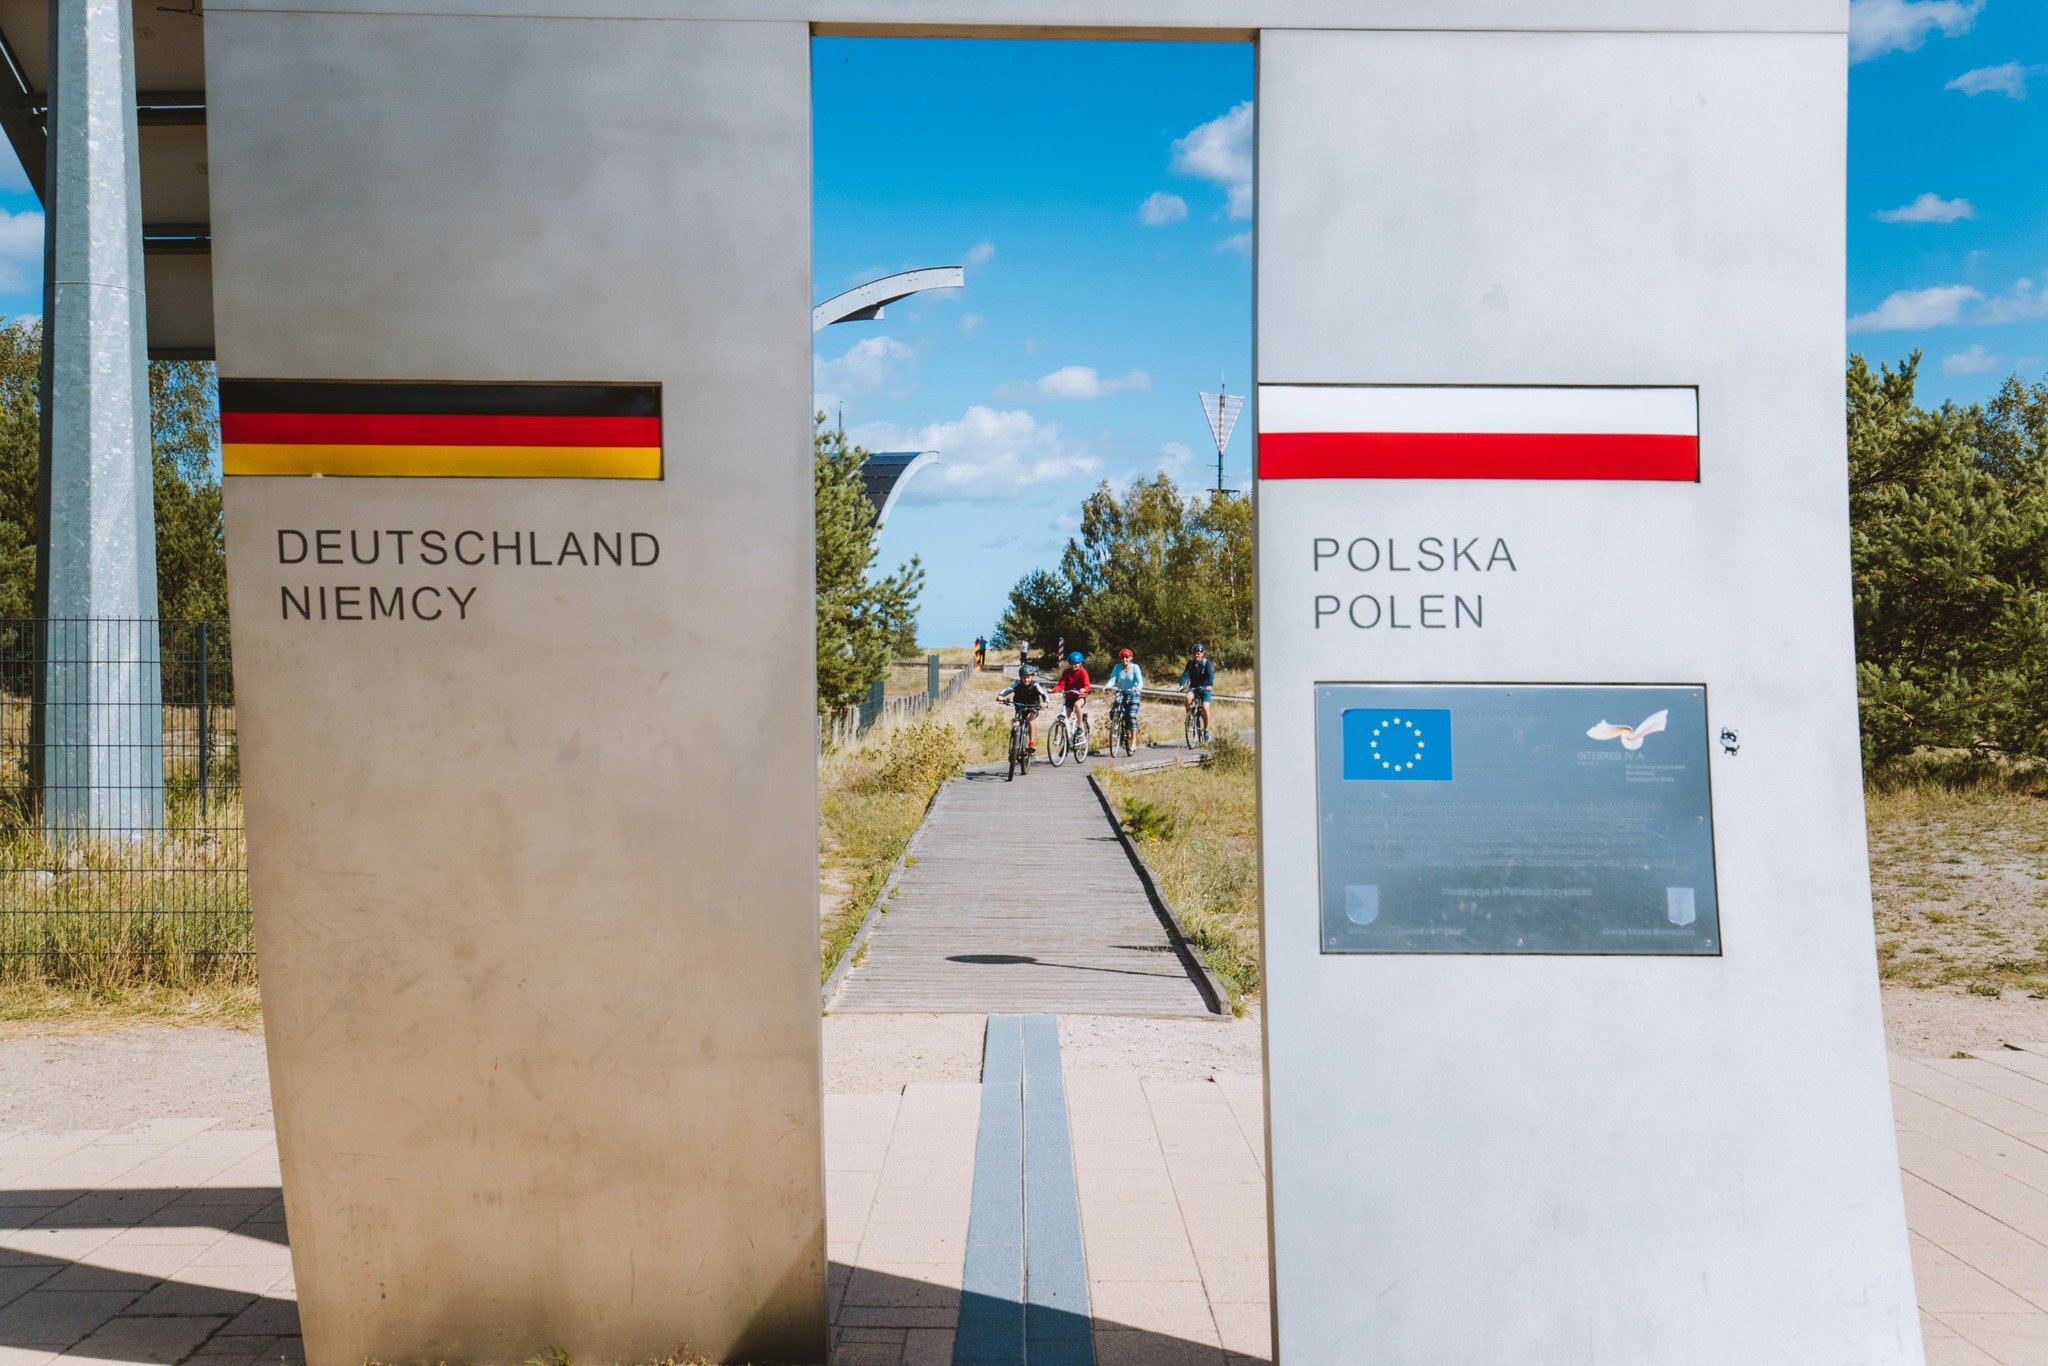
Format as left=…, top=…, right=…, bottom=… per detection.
left=1868, top=774, right=2048, bottom=999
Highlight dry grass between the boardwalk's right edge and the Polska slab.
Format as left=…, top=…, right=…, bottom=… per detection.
left=1100, top=733, right=1260, bottom=995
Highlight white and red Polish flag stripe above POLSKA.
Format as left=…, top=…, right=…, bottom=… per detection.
left=1260, top=385, right=1700, bottom=481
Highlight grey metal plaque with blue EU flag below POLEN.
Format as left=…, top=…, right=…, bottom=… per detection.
left=1315, top=684, right=1720, bottom=954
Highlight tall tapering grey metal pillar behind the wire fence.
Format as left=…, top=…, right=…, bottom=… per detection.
left=35, top=0, right=164, bottom=838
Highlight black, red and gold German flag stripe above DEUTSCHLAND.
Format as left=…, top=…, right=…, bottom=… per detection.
left=221, top=379, right=662, bottom=479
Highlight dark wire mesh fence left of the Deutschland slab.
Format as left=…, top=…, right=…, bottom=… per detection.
left=0, top=618, right=254, bottom=987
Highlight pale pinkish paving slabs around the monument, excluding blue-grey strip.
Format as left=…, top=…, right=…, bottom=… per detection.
left=19, top=1044, right=2048, bottom=1366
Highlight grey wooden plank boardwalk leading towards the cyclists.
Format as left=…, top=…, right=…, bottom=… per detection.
left=829, top=760, right=1208, bottom=1016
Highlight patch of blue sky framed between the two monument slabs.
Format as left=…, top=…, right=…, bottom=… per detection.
left=811, top=39, right=1251, bottom=643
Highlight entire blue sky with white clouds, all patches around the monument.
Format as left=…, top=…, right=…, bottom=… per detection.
left=0, top=0, right=2048, bottom=643
